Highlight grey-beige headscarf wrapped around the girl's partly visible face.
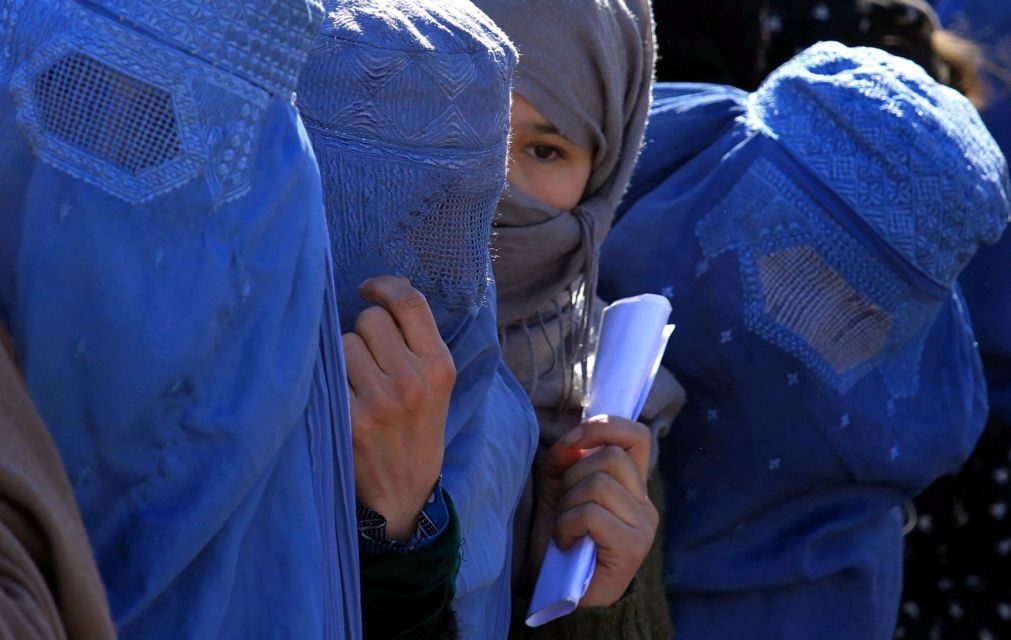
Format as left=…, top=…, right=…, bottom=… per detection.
left=476, top=0, right=683, bottom=444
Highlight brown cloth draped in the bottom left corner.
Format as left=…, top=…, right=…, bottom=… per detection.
left=0, top=332, right=116, bottom=640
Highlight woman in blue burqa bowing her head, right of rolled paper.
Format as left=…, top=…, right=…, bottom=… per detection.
left=601, top=42, right=1009, bottom=640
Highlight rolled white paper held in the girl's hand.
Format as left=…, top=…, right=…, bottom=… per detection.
left=527, top=293, right=674, bottom=627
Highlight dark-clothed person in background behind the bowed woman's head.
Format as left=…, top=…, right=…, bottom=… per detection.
left=656, top=0, right=985, bottom=107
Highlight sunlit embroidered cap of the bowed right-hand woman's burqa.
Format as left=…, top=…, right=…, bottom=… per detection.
left=751, top=42, right=1011, bottom=287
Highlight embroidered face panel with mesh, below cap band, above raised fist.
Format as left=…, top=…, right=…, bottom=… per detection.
left=307, top=136, right=506, bottom=308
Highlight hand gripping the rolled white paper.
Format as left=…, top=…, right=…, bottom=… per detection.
left=530, top=416, right=659, bottom=607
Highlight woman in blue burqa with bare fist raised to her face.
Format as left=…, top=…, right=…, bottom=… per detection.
left=297, top=0, right=536, bottom=638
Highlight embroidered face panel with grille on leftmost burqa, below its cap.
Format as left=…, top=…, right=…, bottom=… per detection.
left=11, top=2, right=295, bottom=204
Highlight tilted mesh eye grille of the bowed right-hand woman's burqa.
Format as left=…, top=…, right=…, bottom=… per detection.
left=758, top=247, right=892, bottom=374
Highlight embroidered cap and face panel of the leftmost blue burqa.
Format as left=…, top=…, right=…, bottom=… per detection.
left=2, top=0, right=321, bottom=205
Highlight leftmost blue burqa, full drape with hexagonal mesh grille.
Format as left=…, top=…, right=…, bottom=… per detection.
left=0, top=0, right=360, bottom=639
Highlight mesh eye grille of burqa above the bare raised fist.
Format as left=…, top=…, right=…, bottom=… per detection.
left=407, top=187, right=498, bottom=305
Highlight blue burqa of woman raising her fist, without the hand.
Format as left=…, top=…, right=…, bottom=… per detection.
left=297, top=0, right=536, bottom=638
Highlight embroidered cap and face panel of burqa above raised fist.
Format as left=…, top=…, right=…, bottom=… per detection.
left=296, top=5, right=513, bottom=308
